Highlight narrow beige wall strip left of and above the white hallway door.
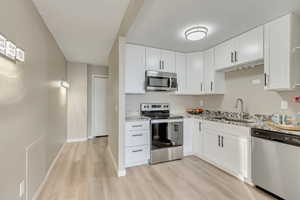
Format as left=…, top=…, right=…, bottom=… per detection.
left=87, top=65, right=109, bottom=136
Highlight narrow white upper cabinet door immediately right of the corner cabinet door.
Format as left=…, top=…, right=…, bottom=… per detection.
left=204, top=49, right=215, bottom=93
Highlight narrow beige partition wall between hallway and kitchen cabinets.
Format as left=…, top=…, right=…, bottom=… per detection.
left=108, top=37, right=126, bottom=172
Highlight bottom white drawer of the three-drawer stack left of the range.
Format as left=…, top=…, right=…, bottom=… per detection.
left=125, top=145, right=148, bottom=167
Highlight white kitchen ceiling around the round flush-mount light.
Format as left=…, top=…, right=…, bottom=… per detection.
left=127, top=0, right=300, bottom=52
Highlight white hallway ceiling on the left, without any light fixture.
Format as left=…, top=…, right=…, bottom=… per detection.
left=32, top=0, right=129, bottom=65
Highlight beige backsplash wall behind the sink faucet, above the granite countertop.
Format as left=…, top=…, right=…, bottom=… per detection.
left=199, top=66, right=300, bottom=114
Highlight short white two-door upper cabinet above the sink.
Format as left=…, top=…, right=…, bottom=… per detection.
left=215, top=26, right=264, bottom=70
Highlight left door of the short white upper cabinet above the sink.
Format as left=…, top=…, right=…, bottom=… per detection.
left=215, top=40, right=234, bottom=70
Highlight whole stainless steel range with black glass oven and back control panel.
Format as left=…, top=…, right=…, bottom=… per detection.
left=141, top=104, right=183, bottom=164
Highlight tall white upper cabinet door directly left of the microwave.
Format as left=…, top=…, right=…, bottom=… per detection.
left=125, top=44, right=145, bottom=94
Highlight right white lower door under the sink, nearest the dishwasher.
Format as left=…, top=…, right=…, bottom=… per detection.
left=222, top=135, right=246, bottom=175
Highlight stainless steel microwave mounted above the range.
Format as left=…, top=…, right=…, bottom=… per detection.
left=146, top=70, right=178, bottom=91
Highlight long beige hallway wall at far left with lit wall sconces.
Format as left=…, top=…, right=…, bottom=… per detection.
left=0, top=0, right=67, bottom=200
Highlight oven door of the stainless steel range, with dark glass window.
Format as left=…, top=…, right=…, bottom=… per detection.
left=150, top=120, right=183, bottom=164
